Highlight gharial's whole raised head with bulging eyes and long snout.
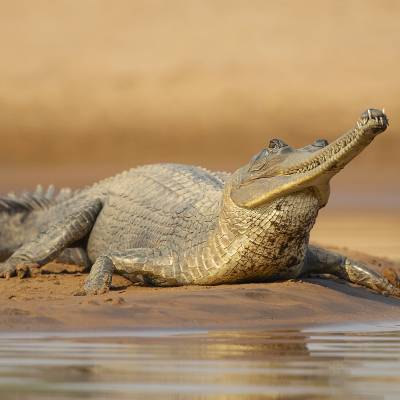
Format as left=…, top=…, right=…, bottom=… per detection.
left=230, top=108, right=389, bottom=208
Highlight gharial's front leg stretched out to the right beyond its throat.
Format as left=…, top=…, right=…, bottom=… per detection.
left=302, top=245, right=400, bottom=296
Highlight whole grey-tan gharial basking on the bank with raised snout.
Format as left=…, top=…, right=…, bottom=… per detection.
left=0, top=109, right=400, bottom=296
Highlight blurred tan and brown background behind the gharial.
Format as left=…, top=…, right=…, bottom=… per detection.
left=0, top=0, right=400, bottom=256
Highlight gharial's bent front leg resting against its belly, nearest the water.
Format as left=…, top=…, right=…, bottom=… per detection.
left=83, top=248, right=182, bottom=294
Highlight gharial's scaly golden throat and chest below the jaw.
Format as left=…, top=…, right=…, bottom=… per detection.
left=179, top=191, right=319, bottom=285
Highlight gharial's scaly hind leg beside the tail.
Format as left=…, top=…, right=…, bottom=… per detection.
left=0, top=200, right=102, bottom=278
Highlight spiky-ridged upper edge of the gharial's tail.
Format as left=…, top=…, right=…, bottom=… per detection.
left=0, top=185, right=76, bottom=214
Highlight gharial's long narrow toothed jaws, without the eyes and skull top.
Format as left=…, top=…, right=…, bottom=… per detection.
left=231, top=108, right=389, bottom=208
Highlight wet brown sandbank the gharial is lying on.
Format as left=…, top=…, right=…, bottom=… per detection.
left=0, top=248, right=400, bottom=331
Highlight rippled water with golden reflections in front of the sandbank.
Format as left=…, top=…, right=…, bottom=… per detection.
left=0, top=325, right=400, bottom=400
